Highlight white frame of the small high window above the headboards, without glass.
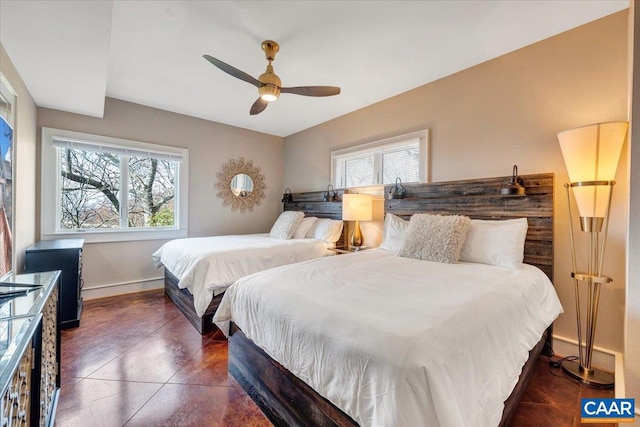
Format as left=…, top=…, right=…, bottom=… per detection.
left=331, top=129, right=430, bottom=188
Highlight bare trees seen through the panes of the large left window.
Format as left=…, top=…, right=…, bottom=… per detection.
left=59, top=148, right=176, bottom=229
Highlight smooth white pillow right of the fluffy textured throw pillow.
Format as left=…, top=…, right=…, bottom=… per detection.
left=460, top=218, right=529, bottom=268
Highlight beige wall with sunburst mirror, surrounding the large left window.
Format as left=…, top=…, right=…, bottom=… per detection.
left=38, top=98, right=284, bottom=293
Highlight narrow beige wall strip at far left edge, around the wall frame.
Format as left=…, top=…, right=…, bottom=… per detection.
left=0, top=44, right=37, bottom=272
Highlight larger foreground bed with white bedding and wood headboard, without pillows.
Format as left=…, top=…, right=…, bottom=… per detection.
left=214, top=174, right=562, bottom=426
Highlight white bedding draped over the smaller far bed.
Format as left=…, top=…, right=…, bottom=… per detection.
left=152, top=234, right=329, bottom=316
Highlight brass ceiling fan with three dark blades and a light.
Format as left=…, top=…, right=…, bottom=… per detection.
left=202, top=40, right=340, bottom=116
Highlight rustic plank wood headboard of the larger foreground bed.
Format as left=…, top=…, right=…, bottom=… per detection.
left=385, top=173, right=554, bottom=280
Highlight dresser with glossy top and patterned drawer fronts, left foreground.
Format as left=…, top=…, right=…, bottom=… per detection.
left=0, top=271, right=60, bottom=426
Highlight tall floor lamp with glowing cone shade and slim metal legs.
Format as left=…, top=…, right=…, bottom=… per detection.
left=558, top=122, right=628, bottom=388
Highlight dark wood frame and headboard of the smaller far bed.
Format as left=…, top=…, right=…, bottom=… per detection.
left=164, top=190, right=346, bottom=335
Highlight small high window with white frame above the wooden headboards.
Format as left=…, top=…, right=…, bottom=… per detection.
left=331, top=130, right=429, bottom=188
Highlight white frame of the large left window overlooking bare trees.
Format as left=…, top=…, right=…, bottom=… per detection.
left=40, top=127, right=189, bottom=243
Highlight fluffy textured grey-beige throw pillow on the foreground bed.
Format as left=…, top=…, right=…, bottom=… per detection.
left=398, top=214, right=471, bottom=264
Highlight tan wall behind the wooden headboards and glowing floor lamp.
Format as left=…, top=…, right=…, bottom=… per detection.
left=284, top=11, right=628, bottom=351
